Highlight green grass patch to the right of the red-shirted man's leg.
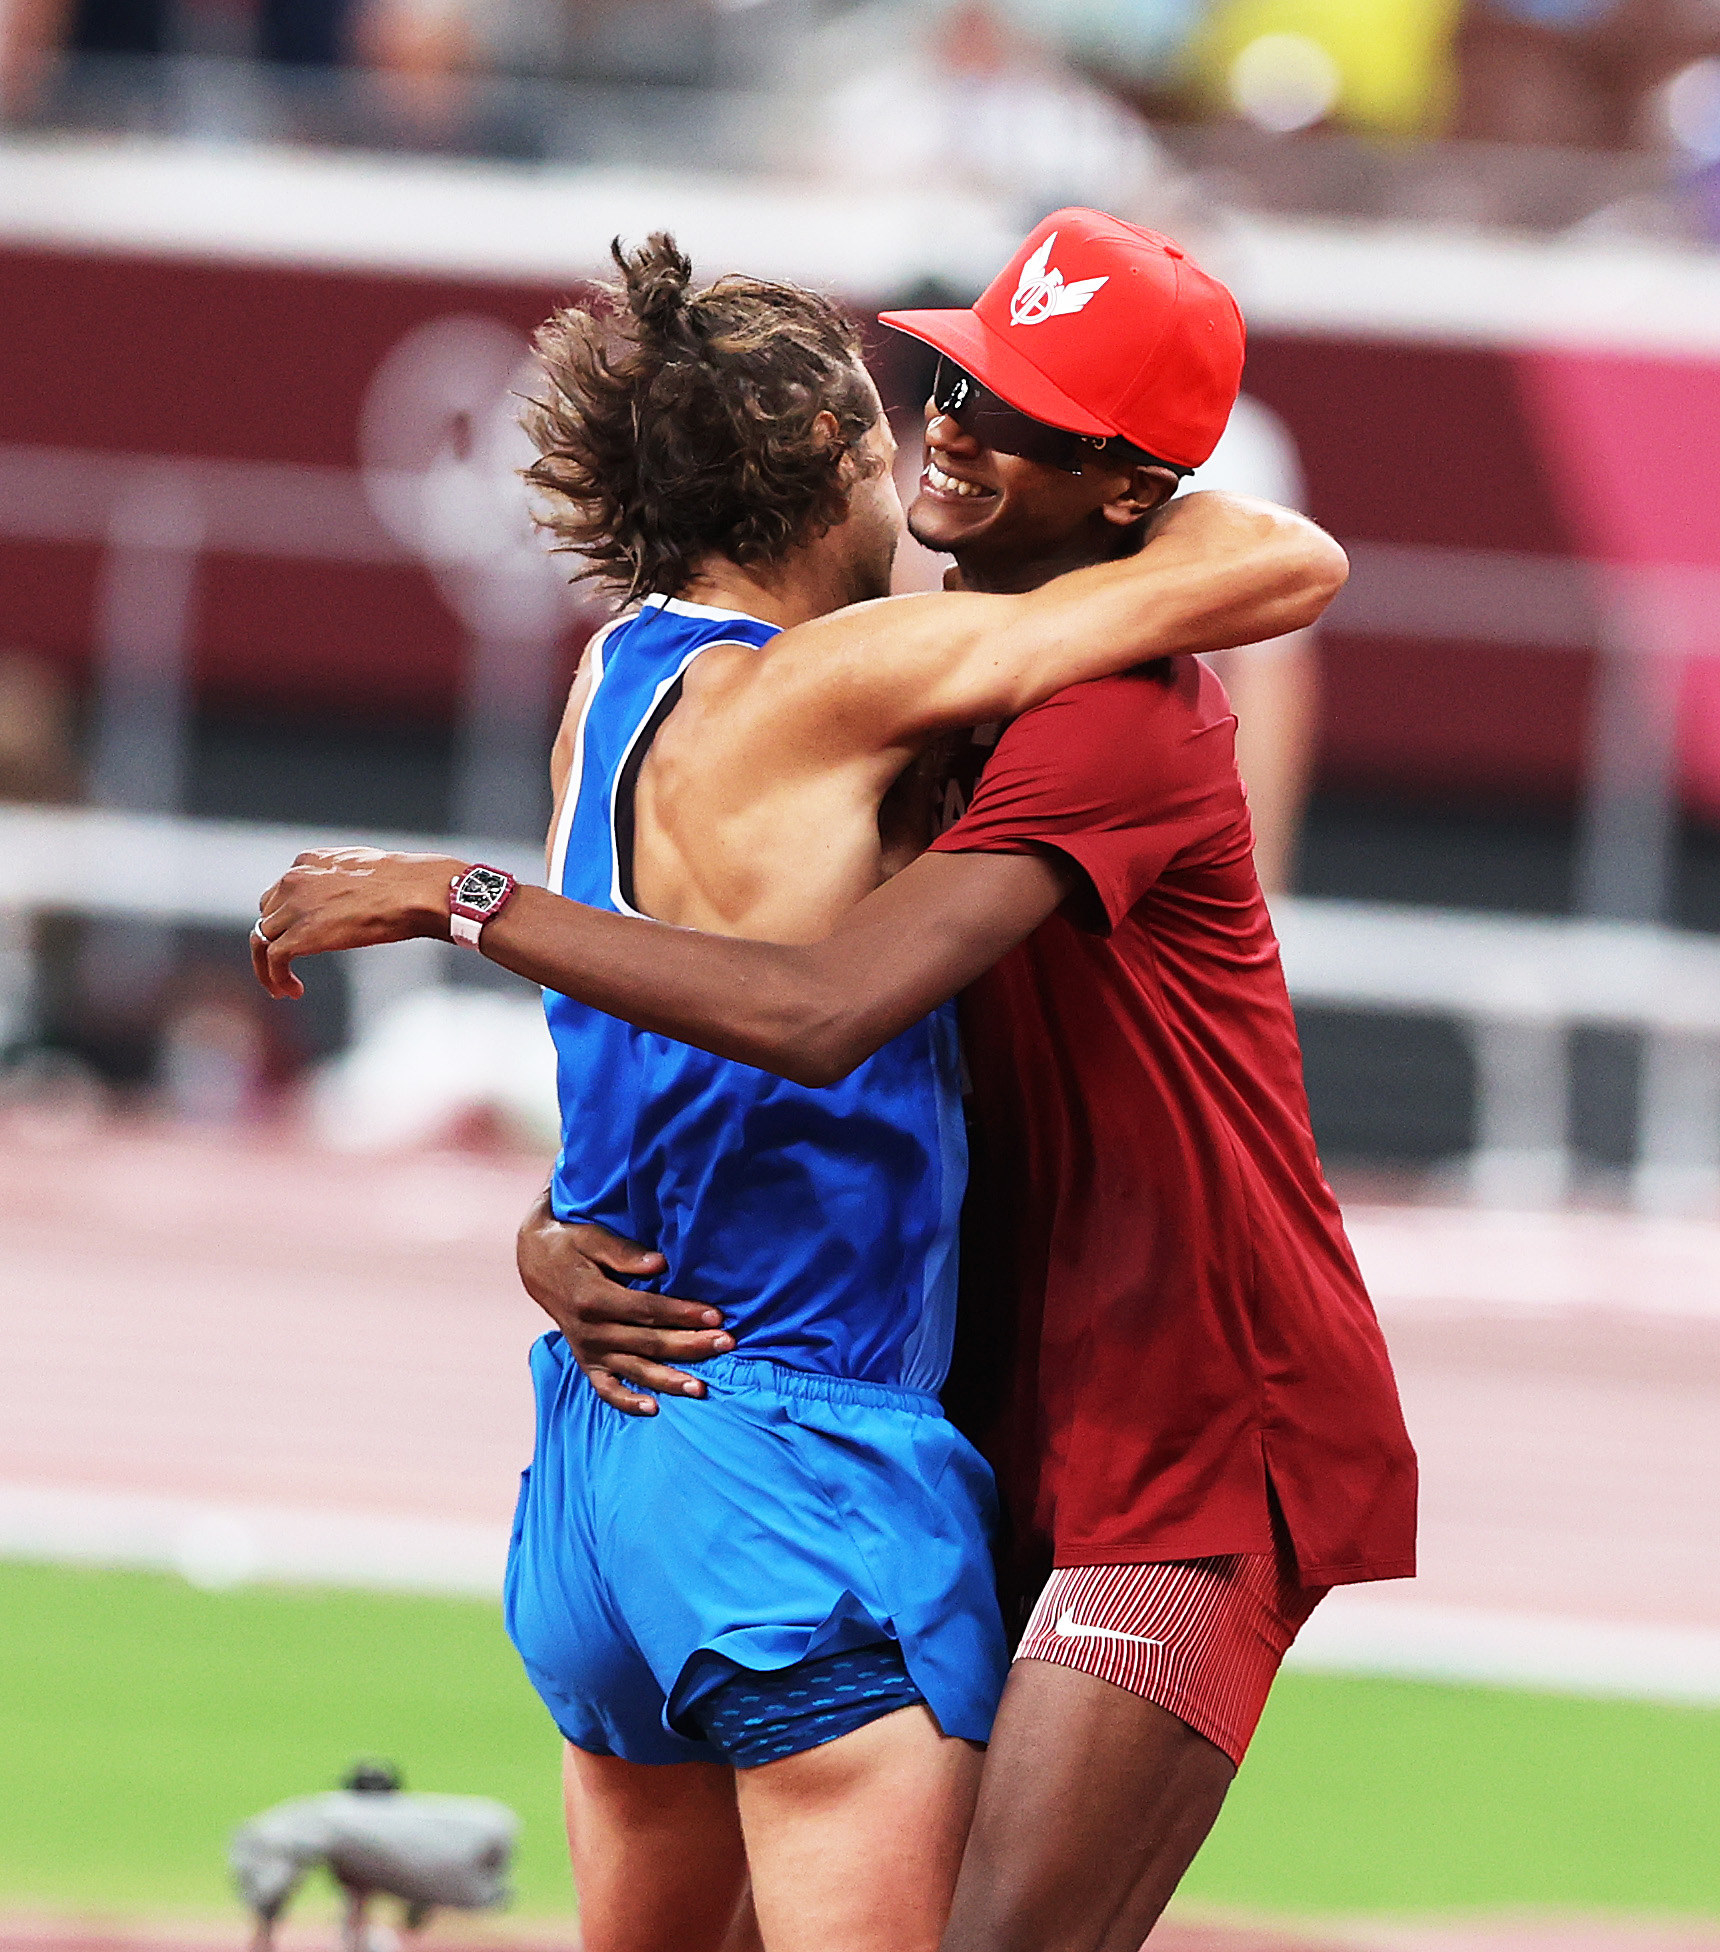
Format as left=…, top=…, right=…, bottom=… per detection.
left=1183, top=1673, right=1720, bottom=1917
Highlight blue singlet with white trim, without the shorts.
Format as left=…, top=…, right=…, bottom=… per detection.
left=545, top=597, right=966, bottom=1390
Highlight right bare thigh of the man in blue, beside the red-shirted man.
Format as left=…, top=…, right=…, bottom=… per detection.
left=734, top=1708, right=982, bottom=1952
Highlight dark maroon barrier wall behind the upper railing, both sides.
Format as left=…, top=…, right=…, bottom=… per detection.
left=0, top=250, right=1720, bottom=804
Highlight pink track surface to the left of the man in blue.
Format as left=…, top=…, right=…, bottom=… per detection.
left=0, top=1122, right=545, bottom=1525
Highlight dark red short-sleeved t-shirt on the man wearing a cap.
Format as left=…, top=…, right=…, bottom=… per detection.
left=933, top=658, right=1415, bottom=1616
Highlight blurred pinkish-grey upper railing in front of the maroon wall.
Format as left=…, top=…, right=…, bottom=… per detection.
left=0, top=437, right=1720, bottom=923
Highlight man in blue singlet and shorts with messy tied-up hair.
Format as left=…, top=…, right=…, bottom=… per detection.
left=254, top=238, right=1335, bottom=1952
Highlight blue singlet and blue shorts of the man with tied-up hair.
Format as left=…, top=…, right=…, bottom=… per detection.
left=495, top=597, right=1005, bottom=1763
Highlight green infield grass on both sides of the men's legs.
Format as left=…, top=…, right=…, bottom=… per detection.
left=0, top=1564, right=1720, bottom=1917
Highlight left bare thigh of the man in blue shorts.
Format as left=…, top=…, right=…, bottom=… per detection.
left=562, top=1743, right=752, bottom=1952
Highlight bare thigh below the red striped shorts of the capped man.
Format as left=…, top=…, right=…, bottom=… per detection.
left=943, top=1661, right=1236, bottom=1952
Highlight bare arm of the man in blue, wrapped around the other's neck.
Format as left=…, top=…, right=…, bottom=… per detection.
left=748, top=494, right=1349, bottom=763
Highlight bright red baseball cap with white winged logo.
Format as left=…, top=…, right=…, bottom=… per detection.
left=879, top=209, right=1244, bottom=468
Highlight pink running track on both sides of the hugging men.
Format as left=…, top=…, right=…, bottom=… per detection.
left=0, top=1115, right=1720, bottom=1653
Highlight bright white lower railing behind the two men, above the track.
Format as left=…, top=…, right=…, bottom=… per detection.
left=0, top=808, right=1720, bottom=1210
